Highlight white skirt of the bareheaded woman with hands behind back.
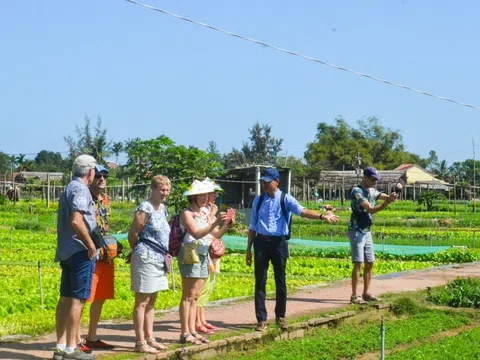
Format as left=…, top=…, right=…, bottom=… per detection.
left=130, top=251, right=168, bottom=294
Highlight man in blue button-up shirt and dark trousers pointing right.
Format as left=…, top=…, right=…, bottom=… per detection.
left=246, top=168, right=338, bottom=331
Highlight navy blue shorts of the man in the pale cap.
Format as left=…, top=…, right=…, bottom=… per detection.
left=60, top=250, right=95, bottom=300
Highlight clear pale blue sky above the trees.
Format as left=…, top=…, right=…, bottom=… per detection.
left=0, top=0, right=480, bottom=164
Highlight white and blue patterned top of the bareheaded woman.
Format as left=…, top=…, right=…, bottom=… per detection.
left=134, top=200, right=170, bottom=261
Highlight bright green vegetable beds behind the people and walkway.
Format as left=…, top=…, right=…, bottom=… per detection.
left=0, top=201, right=480, bottom=337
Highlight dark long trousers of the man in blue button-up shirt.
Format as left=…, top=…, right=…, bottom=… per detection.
left=253, top=237, right=288, bottom=322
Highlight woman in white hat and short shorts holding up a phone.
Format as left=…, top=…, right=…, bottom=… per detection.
left=178, top=180, right=229, bottom=345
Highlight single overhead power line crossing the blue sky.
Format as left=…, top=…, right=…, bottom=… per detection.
left=125, top=0, right=480, bottom=110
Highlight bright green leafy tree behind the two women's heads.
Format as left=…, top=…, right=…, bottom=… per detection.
left=124, top=135, right=225, bottom=209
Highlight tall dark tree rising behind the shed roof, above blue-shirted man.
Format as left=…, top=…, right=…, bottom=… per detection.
left=223, top=122, right=283, bottom=167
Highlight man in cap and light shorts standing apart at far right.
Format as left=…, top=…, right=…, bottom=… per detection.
left=348, top=167, right=402, bottom=305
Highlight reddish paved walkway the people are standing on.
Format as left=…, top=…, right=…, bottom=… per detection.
left=0, top=263, right=480, bottom=360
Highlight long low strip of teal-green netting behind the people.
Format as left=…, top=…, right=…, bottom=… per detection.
left=114, top=234, right=451, bottom=255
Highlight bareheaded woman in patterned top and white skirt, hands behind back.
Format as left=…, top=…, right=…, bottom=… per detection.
left=128, top=175, right=170, bottom=354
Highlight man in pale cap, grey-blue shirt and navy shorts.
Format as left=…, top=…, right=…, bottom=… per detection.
left=53, top=155, right=97, bottom=360
